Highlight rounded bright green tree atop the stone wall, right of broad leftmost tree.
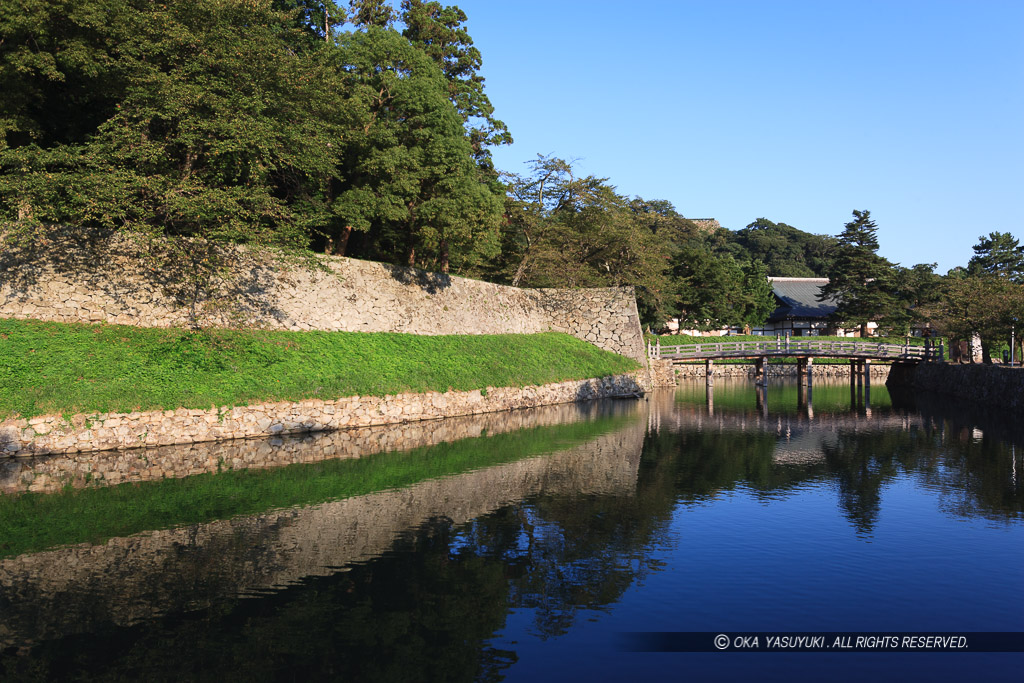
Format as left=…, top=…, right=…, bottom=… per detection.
left=331, top=27, right=502, bottom=272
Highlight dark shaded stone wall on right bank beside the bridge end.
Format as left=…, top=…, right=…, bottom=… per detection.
left=893, top=362, right=1024, bottom=412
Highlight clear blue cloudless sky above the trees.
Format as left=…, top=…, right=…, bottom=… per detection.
left=445, top=0, right=1024, bottom=273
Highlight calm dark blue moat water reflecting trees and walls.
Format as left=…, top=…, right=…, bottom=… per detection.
left=0, top=379, right=1024, bottom=681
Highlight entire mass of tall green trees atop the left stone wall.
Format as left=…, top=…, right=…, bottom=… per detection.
left=0, top=0, right=507, bottom=278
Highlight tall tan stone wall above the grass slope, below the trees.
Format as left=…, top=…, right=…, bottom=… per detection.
left=0, top=235, right=645, bottom=364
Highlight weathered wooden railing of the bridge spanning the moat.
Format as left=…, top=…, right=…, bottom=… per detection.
left=647, top=337, right=944, bottom=360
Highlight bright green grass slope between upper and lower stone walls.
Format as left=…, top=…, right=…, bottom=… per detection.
left=0, top=319, right=639, bottom=420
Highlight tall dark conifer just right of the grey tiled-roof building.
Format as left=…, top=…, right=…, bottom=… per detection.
left=819, top=210, right=898, bottom=337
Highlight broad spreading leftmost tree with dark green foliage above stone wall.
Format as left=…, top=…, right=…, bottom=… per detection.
left=0, top=0, right=345, bottom=248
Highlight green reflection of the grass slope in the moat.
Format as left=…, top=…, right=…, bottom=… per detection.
left=0, top=416, right=635, bottom=558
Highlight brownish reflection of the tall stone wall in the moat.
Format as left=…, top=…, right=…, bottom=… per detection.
left=0, top=403, right=645, bottom=647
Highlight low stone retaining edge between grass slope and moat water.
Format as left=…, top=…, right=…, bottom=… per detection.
left=0, top=370, right=647, bottom=457
